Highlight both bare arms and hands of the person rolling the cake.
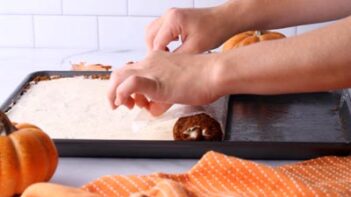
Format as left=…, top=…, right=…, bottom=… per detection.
left=108, top=0, right=351, bottom=115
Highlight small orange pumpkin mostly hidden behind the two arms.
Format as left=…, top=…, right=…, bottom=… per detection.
left=222, top=31, right=285, bottom=52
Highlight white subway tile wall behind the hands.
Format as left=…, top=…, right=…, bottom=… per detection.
left=0, top=0, right=336, bottom=50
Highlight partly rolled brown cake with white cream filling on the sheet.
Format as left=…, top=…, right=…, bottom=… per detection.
left=7, top=76, right=223, bottom=140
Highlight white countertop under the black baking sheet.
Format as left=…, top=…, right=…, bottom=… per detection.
left=0, top=49, right=300, bottom=186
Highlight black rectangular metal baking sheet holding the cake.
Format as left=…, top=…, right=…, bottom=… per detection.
left=1, top=71, right=351, bottom=159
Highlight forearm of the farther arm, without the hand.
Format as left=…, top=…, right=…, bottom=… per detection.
left=217, top=0, right=351, bottom=34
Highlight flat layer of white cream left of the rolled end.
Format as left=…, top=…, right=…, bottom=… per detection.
left=7, top=77, right=178, bottom=140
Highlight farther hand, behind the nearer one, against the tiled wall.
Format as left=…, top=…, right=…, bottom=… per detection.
left=145, top=5, right=235, bottom=53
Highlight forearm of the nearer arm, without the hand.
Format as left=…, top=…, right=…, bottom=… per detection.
left=214, top=17, right=351, bottom=95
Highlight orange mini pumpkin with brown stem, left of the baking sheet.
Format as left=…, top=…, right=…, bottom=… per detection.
left=0, top=111, right=58, bottom=197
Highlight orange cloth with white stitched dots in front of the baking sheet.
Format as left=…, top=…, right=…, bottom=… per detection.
left=83, top=151, right=351, bottom=197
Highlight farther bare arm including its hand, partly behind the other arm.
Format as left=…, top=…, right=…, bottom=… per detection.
left=146, top=0, right=351, bottom=53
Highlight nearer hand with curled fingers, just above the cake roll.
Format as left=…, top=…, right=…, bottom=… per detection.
left=108, top=51, right=220, bottom=116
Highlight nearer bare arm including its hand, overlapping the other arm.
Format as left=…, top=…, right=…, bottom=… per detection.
left=109, top=17, right=351, bottom=115
